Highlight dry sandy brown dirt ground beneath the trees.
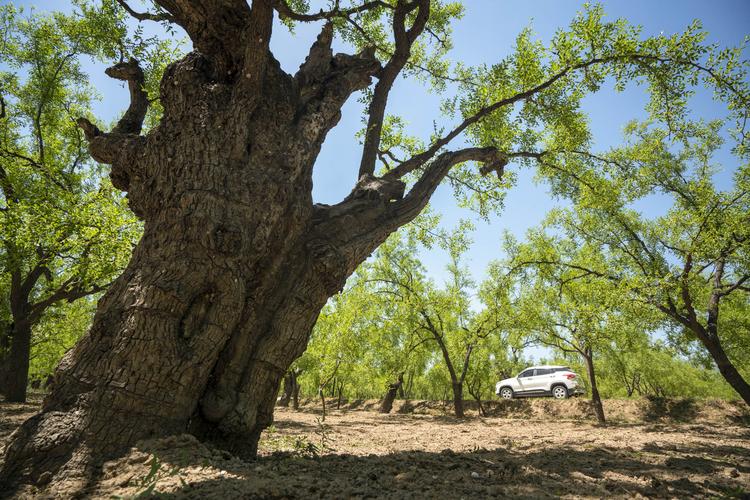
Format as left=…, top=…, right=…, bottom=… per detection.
left=0, top=399, right=750, bottom=499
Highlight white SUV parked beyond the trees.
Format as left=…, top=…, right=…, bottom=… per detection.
left=495, top=365, right=583, bottom=399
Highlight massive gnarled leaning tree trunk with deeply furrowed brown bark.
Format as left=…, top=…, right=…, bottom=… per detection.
left=0, top=0, right=524, bottom=489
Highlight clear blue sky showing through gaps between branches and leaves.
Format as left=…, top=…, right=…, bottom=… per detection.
left=7, top=0, right=750, bottom=292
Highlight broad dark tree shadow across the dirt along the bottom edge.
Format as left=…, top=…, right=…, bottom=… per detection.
left=134, top=440, right=747, bottom=498
